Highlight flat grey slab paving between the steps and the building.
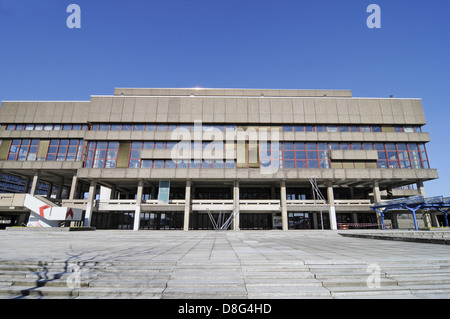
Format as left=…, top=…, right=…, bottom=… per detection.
left=0, top=230, right=450, bottom=265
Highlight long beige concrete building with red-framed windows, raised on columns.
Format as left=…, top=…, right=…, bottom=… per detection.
left=0, top=88, right=440, bottom=230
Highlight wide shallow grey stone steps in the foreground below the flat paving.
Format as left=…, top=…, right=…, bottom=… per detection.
left=0, top=259, right=450, bottom=299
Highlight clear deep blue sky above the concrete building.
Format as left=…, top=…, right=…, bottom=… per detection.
left=0, top=0, right=450, bottom=196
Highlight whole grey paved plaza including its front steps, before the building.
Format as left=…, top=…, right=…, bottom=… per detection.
left=0, top=230, right=450, bottom=298
